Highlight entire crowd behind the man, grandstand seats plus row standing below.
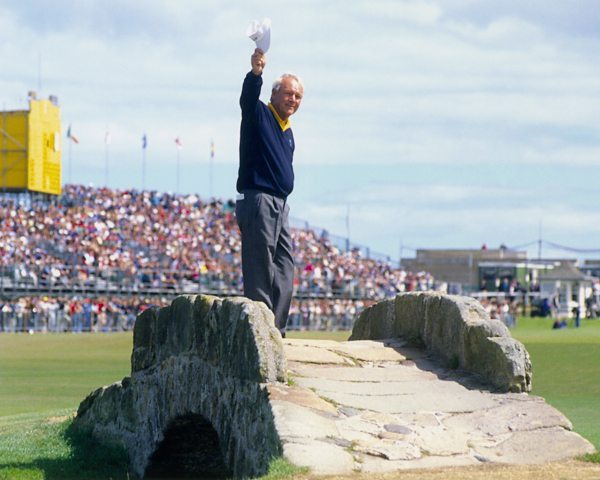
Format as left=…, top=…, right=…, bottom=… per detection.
left=0, top=185, right=434, bottom=331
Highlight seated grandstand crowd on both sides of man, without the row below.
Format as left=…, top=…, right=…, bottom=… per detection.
left=0, top=185, right=433, bottom=298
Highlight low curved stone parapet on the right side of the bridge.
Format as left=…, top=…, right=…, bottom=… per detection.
left=350, top=292, right=532, bottom=392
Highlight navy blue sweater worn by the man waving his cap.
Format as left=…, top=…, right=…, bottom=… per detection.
left=237, top=72, right=295, bottom=198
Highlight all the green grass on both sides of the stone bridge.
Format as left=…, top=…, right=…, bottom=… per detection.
left=0, top=318, right=600, bottom=480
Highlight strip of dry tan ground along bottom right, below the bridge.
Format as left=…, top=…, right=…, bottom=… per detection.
left=294, top=460, right=600, bottom=480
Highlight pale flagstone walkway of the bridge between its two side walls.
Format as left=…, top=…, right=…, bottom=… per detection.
left=269, top=339, right=594, bottom=474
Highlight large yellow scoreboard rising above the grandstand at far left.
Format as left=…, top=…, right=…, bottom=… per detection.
left=0, top=97, right=61, bottom=195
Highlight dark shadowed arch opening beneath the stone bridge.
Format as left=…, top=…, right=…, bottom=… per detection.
left=144, top=414, right=232, bottom=479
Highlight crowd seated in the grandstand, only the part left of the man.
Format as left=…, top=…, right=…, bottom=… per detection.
left=0, top=185, right=241, bottom=289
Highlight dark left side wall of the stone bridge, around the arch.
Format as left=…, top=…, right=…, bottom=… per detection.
left=75, top=296, right=286, bottom=477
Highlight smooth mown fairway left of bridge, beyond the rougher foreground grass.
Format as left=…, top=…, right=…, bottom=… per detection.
left=0, top=333, right=133, bottom=416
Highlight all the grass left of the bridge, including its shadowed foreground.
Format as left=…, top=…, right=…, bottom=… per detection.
left=0, top=333, right=133, bottom=480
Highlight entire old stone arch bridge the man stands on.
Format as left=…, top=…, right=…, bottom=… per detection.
left=75, top=293, right=594, bottom=478
